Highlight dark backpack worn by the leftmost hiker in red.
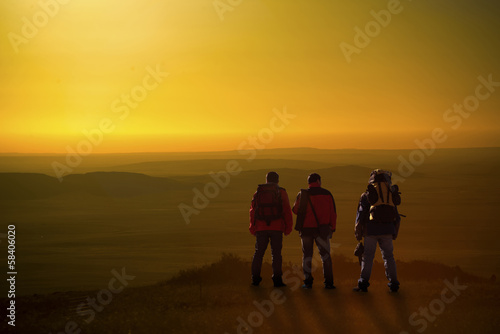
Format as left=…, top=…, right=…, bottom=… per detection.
left=255, top=183, right=283, bottom=226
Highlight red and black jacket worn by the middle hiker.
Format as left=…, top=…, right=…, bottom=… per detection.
left=292, top=182, right=337, bottom=232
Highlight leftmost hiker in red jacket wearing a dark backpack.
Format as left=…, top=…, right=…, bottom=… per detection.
left=249, top=172, right=293, bottom=287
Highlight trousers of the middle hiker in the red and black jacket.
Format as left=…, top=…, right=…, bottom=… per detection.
left=301, top=233, right=333, bottom=285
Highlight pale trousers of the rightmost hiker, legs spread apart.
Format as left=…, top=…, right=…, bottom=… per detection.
left=358, top=234, right=399, bottom=287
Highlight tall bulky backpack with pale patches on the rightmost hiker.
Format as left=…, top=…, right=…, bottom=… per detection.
left=367, top=169, right=401, bottom=223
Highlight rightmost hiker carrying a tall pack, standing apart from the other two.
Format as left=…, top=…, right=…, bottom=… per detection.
left=354, top=169, right=401, bottom=292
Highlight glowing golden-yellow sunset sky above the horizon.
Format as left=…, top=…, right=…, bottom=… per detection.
left=0, top=0, right=500, bottom=153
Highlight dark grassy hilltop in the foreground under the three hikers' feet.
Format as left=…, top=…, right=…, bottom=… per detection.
left=0, top=254, right=500, bottom=334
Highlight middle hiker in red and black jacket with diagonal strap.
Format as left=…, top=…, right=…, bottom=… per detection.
left=293, top=173, right=337, bottom=289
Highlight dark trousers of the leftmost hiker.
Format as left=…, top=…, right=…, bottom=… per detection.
left=252, top=231, right=283, bottom=282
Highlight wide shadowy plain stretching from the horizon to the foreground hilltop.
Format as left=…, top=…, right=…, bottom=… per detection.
left=0, top=148, right=500, bottom=295
